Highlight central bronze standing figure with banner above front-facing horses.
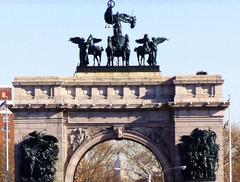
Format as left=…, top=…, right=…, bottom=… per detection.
left=104, top=0, right=136, bottom=66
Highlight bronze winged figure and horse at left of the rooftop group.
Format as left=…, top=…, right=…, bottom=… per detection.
left=69, top=34, right=104, bottom=67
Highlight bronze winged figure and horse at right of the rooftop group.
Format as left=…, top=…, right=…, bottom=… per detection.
left=134, top=34, right=168, bottom=66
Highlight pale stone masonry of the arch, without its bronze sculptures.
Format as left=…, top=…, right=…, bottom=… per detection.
left=11, top=66, right=228, bottom=182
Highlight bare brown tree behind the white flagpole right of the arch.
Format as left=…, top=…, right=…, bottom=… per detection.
left=223, top=126, right=240, bottom=182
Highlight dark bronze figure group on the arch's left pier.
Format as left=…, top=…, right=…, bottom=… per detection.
left=21, top=131, right=59, bottom=182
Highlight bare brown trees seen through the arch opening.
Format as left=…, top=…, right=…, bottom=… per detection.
left=74, top=140, right=162, bottom=182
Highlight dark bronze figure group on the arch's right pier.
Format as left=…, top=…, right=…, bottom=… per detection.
left=179, top=128, right=219, bottom=181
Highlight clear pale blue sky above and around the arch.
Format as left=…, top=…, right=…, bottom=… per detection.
left=0, top=0, right=240, bottom=122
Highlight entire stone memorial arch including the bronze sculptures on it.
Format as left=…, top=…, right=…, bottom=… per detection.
left=11, top=0, right=228, bottom=182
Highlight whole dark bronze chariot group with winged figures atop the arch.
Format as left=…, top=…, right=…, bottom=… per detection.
left=69, top=0, right=168, bottom=67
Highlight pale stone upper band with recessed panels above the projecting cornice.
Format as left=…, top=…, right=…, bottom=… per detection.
left=13, top=73, right=223, bottom=105
